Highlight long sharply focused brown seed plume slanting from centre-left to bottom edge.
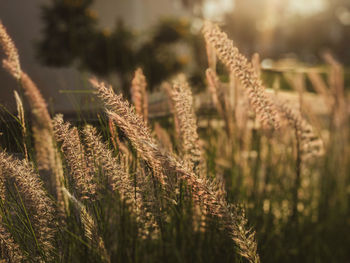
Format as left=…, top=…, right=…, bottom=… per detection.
left=91, top=79, right=260, bottom=263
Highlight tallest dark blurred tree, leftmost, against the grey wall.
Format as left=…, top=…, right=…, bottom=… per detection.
left=39, top=0, right=96, bottom=66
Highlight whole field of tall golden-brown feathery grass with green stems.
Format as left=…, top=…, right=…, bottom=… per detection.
left=0, top=19, right=350, bottom=263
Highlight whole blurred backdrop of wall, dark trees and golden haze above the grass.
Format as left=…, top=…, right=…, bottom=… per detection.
left=0, top=0, right=350, bottom=112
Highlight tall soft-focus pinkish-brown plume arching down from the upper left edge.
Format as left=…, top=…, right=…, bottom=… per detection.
left=0, top=22, right=65, bottom=209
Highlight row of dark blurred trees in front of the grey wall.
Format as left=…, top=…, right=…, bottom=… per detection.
left=38, top=0, right=204, bottom=96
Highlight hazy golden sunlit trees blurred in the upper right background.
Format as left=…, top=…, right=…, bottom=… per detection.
left=225, top=0, right=350, bottom=65
